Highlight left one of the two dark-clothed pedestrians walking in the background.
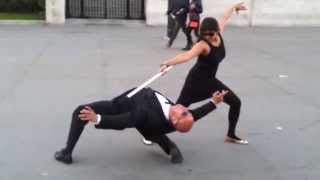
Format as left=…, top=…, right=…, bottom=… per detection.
left=167, top=0, right=192, bottom=50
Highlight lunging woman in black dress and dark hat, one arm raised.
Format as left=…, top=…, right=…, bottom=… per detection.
left=160, top=3, right=248, bottom=144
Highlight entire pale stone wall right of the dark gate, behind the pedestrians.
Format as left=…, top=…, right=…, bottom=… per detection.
left=146, top=0, right=320, bottom=26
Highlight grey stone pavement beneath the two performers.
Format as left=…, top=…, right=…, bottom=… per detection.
left=0, top=23, right=320, bottom=180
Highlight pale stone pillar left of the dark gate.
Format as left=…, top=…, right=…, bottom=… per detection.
left=46, top=0, right=66, bottom=24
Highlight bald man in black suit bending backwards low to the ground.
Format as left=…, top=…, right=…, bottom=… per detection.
left=55, top=88, right=227, bottom=164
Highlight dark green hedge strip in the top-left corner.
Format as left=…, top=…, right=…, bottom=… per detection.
left=0, top=0, right=45, bottom=13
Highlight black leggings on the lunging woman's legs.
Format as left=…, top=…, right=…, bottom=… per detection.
left=176, top=78, right=241, bottom=137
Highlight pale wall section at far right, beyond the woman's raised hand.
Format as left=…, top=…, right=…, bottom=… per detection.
left=252, top=0, right=320, bottom=26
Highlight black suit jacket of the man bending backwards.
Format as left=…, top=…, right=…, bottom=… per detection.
left=96, top=88, right=216, bottom=138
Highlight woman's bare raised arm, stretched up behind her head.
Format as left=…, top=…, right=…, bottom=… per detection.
left=219, top=2, right=247, bottom=33
